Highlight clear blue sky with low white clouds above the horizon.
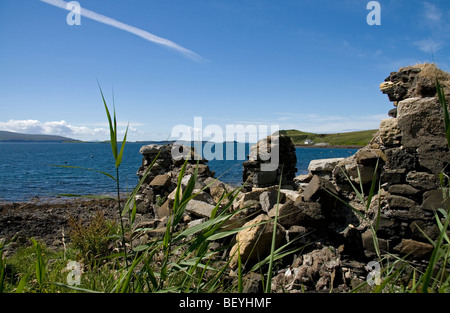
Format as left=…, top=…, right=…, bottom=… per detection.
left=0, top=0, right=450, bottom=141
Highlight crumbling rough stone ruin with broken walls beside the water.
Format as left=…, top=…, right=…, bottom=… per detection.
left=132, top=64, right=450, bottom=292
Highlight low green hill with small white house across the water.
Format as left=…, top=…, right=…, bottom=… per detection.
left=280, top=129, right=378, bottom=146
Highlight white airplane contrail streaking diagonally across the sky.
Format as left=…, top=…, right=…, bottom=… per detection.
left=41, top=0, right=204, bottom=61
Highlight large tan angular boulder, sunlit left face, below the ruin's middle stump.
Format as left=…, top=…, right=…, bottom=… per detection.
left=230, top=214, right=285, bottom=269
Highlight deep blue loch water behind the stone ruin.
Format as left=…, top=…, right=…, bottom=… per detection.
left=0, top=142, right=357, bottom=201
